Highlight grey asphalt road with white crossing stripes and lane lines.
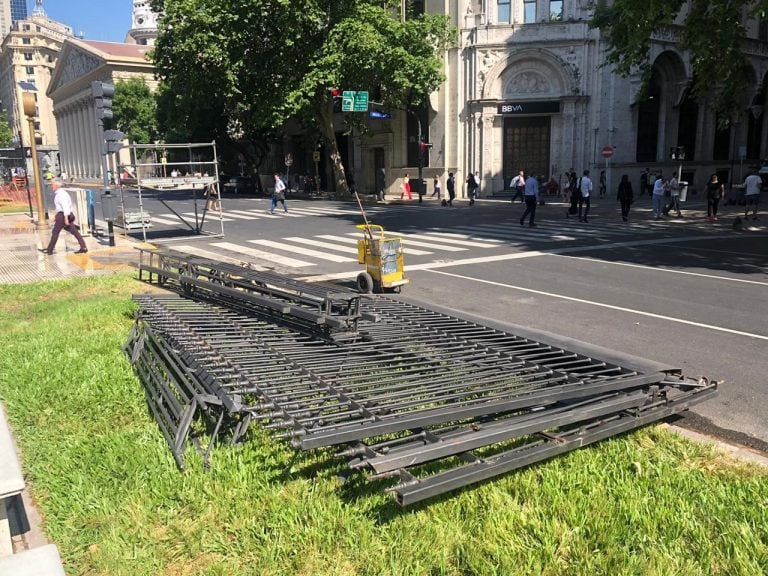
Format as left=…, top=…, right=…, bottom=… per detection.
left=109, top=193, right=768, bottom=451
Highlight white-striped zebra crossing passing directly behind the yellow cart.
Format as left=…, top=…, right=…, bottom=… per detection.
left=164, top=220, right=688, bottom=272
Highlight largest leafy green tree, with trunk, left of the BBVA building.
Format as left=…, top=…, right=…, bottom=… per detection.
left=152, top=0, right=455, bottom=191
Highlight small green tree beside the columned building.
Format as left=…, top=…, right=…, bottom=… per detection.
left=112, top=78, right=158, bottom=144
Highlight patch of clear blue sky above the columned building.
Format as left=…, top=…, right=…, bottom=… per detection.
left=32, top=0, right=133, bottom=42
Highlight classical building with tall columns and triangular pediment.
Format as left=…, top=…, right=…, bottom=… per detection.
left=48, top=38, right=156, bottom=179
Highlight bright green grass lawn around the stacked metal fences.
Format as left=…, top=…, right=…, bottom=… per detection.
left=0, top=275, right=768, bottom=576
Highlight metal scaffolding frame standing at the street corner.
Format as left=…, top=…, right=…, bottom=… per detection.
left=120, top=141, right=224, bottom=242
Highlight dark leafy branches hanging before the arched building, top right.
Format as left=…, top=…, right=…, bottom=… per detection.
left=591, top=0, right=768, bottom=121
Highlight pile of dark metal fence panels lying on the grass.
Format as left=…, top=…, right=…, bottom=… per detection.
left=125, top=251, right=716, bottom=506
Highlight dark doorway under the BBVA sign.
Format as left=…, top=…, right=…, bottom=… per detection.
left=503, top=116, right=552, bottom=180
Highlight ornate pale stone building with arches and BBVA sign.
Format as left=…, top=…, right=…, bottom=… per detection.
left=408, top=0, right=768, bottom=196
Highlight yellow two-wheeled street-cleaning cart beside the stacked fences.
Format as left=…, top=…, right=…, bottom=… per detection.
left=357, top=223, right=409, bottom=294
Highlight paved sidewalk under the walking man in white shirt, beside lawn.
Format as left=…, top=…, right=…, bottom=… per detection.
left=0, top=214, right=138, bottom=284
